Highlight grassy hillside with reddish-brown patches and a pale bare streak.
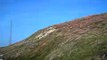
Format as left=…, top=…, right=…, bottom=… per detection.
left=0, top=13, right=107, bottom=60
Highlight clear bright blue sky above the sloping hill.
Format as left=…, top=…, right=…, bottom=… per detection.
left=0, top=0, right=107, bottom=47
